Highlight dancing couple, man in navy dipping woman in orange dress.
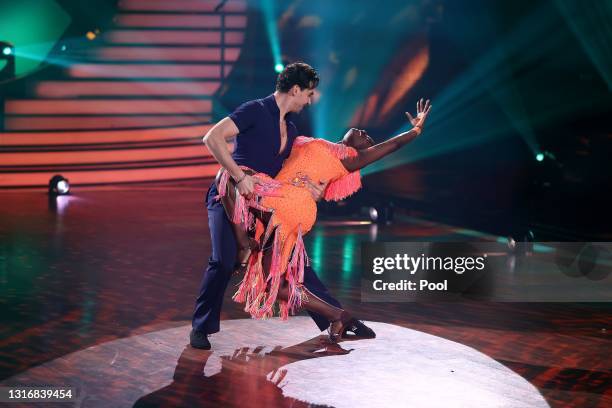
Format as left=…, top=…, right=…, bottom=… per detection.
left=190, top=63, right=431, bottom=349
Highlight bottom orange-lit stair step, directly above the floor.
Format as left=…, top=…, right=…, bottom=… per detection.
left=0, top=163, right=219, bottom=188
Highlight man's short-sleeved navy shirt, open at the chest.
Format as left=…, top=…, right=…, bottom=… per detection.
left=208, top=95, right=298, bottom=205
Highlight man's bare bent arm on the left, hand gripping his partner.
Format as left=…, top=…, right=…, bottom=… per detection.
left=202, top=117, right=257, bottom=196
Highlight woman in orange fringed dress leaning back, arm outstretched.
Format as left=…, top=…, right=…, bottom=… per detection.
left=217, top=99, right=431, bottom=342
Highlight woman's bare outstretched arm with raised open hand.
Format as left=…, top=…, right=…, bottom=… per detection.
left=342, top=99, right=431, bottom=172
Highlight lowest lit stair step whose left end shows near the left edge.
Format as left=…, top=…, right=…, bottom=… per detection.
left=5, top=99, right=212, bottom=115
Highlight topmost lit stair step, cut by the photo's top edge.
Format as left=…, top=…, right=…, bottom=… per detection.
left=118, top=0, right=246, bottom=13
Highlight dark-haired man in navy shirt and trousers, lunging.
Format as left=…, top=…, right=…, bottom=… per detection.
left=189, top=62, right=374, bottom=349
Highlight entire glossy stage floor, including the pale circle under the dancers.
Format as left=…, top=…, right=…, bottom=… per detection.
left=0, top=185, right=612, bottom=407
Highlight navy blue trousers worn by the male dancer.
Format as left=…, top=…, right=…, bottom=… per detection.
left=191, top=187, right=342, bottom=334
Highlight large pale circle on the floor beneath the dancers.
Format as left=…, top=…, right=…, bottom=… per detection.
left=1, top=316, right=548, bottom=408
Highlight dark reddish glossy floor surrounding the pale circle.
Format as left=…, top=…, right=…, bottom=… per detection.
left=0, top=184, right=612, bottom=407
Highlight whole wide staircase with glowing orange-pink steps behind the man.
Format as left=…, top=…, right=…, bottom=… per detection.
left=0, top=0, right=247, bottom=188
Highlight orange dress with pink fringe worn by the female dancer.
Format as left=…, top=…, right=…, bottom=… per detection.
left=219, top=136, right=361, bottom=320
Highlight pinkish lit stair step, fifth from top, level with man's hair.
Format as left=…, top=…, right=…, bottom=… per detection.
left=68, top=64, right=222, bottom=79
